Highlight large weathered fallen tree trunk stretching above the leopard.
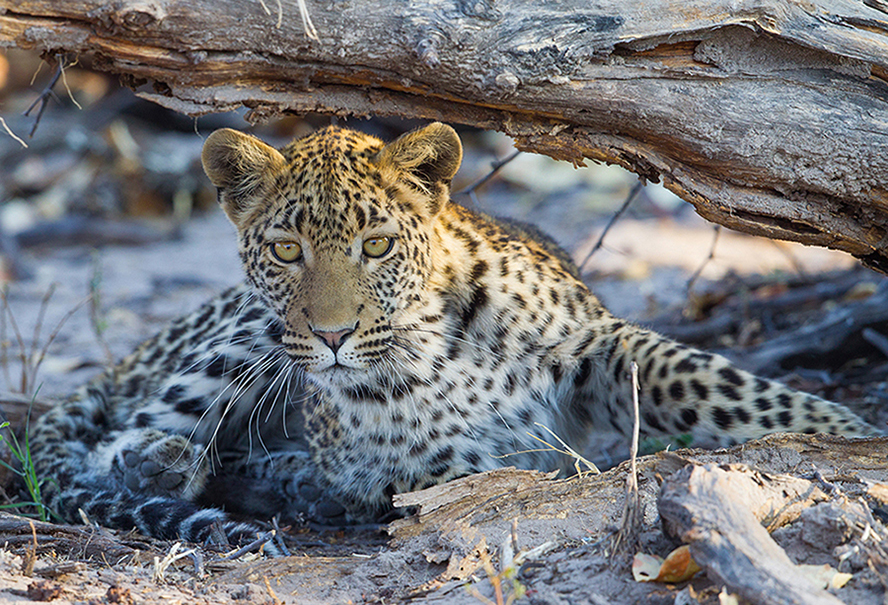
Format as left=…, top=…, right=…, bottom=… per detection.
left=0, top=0, right=888, bottom=271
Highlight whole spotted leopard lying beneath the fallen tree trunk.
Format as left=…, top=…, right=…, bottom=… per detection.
left=30, top=123, right=880, bottom=543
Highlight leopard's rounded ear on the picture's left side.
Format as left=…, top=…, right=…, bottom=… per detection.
left=200, top=128, right=286, bottom=226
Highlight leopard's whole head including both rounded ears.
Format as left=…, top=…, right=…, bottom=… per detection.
left=202, top=123, right=462, bottom=383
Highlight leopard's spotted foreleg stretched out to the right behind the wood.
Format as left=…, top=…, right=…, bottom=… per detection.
left=564, top=312, right=878, bottom=446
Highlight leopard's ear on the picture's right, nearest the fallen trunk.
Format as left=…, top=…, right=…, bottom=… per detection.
left=377, top=122, right=462, bottom=215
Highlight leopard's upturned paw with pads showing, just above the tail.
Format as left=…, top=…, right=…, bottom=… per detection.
left=114, top=429, right=207, bottom=500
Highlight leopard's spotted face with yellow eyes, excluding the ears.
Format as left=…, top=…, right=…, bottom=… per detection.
left=240, top=145, right=429, bottom=374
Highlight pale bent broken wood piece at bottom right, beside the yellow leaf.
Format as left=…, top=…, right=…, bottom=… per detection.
left=657, top=464, right=841, bottom=605
